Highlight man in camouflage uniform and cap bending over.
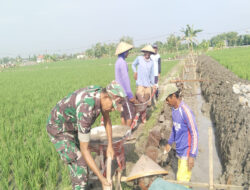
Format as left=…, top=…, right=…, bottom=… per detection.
left=47, top=81, right=126, bottom=190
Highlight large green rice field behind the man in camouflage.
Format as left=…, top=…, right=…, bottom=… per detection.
left=0, top=54, right=176, bottom=190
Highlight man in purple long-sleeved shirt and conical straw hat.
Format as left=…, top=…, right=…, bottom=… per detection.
left=115, top=42, right=136, bottom=126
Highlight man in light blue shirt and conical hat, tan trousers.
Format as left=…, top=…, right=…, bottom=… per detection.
left=132, top=45, right=155, bottom=123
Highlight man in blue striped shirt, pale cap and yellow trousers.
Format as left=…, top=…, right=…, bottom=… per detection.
left=165, top=84, right=198, bottom=182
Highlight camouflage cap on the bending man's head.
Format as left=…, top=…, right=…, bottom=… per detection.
left=106, top=81, right=126, bottom=109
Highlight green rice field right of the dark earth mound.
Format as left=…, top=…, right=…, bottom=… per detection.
left=207, top=47, right=250, bottom=80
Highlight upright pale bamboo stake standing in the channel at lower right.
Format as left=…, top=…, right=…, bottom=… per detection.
left=208, top=127, right=214, bottom=190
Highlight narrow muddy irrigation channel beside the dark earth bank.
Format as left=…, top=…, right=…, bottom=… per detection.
left=170, top=55, right=222, bottom=190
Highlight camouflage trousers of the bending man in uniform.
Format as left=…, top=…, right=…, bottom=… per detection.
left=49, top=131, right=88, bottom=190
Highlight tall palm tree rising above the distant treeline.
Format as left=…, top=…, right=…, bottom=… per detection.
left=181, top=24, right=202, bottom=52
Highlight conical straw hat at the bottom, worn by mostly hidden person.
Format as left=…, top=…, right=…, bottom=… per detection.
left=126, top=155, right=168, bottom=181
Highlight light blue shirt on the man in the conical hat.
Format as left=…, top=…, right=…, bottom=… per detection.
left=132, top=56, right=155, bottom=87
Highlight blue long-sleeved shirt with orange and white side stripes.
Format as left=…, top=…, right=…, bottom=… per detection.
left=168, top=101, right=198, bottom=157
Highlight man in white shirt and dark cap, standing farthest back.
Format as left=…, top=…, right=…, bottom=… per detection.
left=150, top=44, right=161, bottom=98
